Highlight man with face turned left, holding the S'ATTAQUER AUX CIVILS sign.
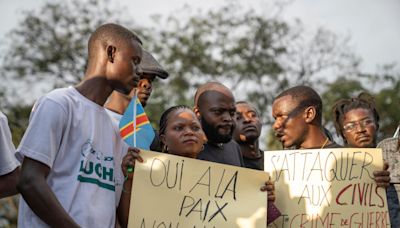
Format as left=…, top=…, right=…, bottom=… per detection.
left=272, top=86, right=390, bottom=182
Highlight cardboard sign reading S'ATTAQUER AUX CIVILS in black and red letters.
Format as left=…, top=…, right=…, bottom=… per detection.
left=264, top=148, right=390, bottom=228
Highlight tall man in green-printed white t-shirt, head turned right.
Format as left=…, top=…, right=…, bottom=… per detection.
left=17, top=24, right=142, bottom=227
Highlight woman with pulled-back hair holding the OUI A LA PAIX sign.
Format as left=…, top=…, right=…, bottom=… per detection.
left=118, top=105, right=275, bottom=227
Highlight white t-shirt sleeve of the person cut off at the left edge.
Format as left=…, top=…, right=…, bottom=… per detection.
left=0, top=112, right=19, bottom=176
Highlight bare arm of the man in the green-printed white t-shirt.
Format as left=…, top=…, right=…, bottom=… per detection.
left=17, top=157, right=79, bottom=227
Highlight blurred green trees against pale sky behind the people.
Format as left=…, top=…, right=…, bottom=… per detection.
left=0, top=0, right=400, bottom=227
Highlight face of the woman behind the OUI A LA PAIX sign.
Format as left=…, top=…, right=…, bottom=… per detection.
left=161, top=109, right=205, bottom=158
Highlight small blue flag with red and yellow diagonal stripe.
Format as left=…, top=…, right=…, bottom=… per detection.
left=119, top=96, right=155, bottom=150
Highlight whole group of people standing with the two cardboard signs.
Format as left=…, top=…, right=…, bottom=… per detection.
left=0, top=24, right=400, bottom=227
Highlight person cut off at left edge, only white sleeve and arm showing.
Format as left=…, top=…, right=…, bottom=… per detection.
left=0, top=111, right=19, bottom=198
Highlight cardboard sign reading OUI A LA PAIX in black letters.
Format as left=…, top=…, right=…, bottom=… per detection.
left=128, top=151, right=268, bottom=228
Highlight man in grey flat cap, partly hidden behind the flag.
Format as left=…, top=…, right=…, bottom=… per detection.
left=104, top=50, right=168, bottom=151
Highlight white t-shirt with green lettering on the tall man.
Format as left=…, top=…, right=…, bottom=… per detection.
left=17, top=87, right=124, bottom=227
